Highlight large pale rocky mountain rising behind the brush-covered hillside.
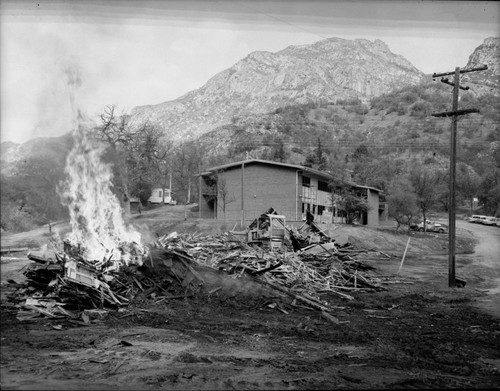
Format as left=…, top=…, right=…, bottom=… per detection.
left=131, top=38, right=424, bottom=140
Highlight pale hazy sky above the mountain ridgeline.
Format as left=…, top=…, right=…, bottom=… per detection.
left=0, top=0, right=500, bottom=142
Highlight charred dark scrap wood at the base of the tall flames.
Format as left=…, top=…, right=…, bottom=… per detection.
left=8, top=242, right=212, bottom=320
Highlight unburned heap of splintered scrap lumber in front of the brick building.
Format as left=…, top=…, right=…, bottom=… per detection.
left=150, top=232, right=383, bottom=299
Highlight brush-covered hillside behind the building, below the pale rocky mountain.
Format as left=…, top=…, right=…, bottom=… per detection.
left=199, top=81, right=500, bottom=193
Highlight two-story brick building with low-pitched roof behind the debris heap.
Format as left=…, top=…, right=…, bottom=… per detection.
left=199, top=159, right=385, bottom=226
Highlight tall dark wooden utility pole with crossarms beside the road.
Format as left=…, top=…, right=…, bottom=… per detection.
left=432, top=65, right=488, bottom=288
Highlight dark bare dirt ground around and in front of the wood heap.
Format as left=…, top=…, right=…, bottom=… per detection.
left=0, top=208, right=500, bottom=390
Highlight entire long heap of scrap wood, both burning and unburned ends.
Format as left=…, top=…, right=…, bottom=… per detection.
left=4, top=228, right=382, bottom=321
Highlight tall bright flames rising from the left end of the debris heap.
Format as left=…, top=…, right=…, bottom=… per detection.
left=58, top=65, right=145, bottom=268
